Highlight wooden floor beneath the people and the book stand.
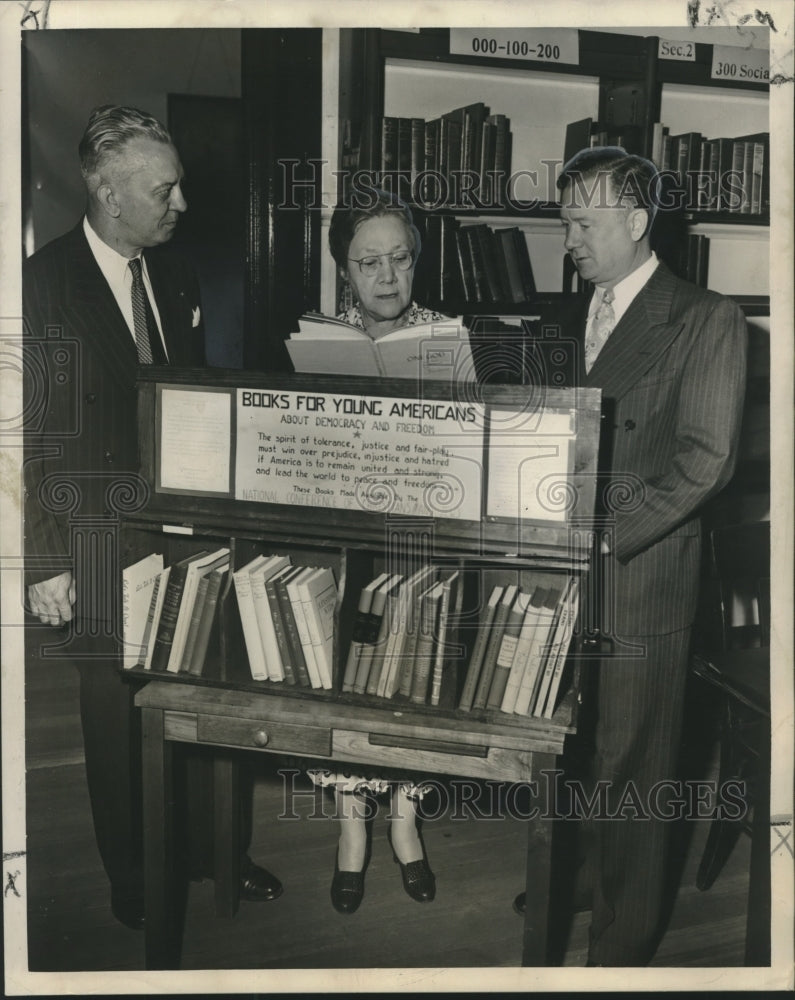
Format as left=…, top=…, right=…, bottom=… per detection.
left=21, top=640, right=760, bottom=971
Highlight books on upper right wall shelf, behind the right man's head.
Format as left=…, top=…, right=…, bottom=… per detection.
left=564, top=118, right=770, bottom=215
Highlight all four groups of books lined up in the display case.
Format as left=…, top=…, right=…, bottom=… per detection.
left=123, top=548, right=579, bottom=719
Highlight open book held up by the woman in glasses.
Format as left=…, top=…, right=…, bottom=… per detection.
left=286, top=313, right=475, bottom=381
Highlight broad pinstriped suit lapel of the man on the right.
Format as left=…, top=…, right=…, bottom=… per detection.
left=585, top=264, right=684, bottom=399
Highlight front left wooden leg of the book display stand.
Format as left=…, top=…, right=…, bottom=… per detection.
left=142, top=708, right=181, bottom=969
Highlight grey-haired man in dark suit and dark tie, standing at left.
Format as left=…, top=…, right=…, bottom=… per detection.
left=23, top=106, right=281, bottom=928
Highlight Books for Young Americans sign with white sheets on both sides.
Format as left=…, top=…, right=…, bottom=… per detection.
left=156, top=385, right=577, bottom=523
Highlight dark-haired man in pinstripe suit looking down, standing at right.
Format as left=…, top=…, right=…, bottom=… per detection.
left=512, top=147, right=747, bottom=966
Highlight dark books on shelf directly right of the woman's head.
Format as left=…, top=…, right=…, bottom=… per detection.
left=417, top=215, right=536, bottom=304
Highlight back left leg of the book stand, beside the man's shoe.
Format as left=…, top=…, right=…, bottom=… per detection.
left=213, top=752, right=240, bottom=917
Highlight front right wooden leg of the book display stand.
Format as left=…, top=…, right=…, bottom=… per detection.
left=522, top=754, right=555, bottom=967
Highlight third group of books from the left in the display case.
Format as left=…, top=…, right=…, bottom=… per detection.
left=342, top=565, right=463, bottom=705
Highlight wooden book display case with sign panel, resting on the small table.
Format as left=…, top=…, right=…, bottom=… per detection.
left=123, top=362, right=600, bottom=740
